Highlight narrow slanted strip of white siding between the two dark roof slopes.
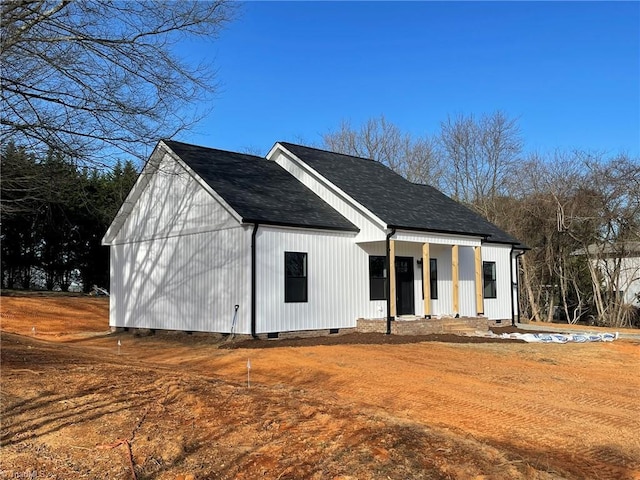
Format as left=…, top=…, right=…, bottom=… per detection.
left=269, top=151, right=386, bottom=242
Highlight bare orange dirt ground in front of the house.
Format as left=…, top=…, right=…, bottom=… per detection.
left=0, top=296, right=640, bottom=480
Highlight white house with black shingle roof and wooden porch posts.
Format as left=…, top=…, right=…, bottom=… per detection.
left=103, top=140, right=526, bottom=336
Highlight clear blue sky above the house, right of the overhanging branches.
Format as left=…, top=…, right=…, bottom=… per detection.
left=176, top=2, right=640, bottom=157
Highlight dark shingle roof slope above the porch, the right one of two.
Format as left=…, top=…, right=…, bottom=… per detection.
left=280, top=142, right=520, bottom=245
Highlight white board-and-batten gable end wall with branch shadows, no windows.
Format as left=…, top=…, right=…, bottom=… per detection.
left=109, top=155, right=251, bottom=333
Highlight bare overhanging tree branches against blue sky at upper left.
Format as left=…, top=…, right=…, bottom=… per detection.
left=0, top=0, right=235, bottom=162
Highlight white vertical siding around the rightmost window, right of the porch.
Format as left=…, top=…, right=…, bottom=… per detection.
left=482, top=244, right=513, bottom=320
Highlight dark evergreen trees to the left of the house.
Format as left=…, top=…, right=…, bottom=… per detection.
left=0, top=142, right=138, bottom=292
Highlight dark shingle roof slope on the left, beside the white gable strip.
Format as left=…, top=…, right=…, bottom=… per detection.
left=164, top=140, right=358, bottom=231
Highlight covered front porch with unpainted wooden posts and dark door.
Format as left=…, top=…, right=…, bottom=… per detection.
left=359, top=232, right=490, bottom=320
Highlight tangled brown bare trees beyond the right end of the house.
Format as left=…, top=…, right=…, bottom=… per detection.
left=496, top=151, right=640, bottom=326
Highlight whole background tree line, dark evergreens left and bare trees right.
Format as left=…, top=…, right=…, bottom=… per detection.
left=0, top=112, right=640, bottom=326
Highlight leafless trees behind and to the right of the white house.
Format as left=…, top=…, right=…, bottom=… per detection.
left=322, top=111, right=640, bottom=326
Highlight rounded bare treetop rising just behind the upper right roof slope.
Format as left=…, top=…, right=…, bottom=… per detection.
left=323, top=116, right=441, bottom=185
